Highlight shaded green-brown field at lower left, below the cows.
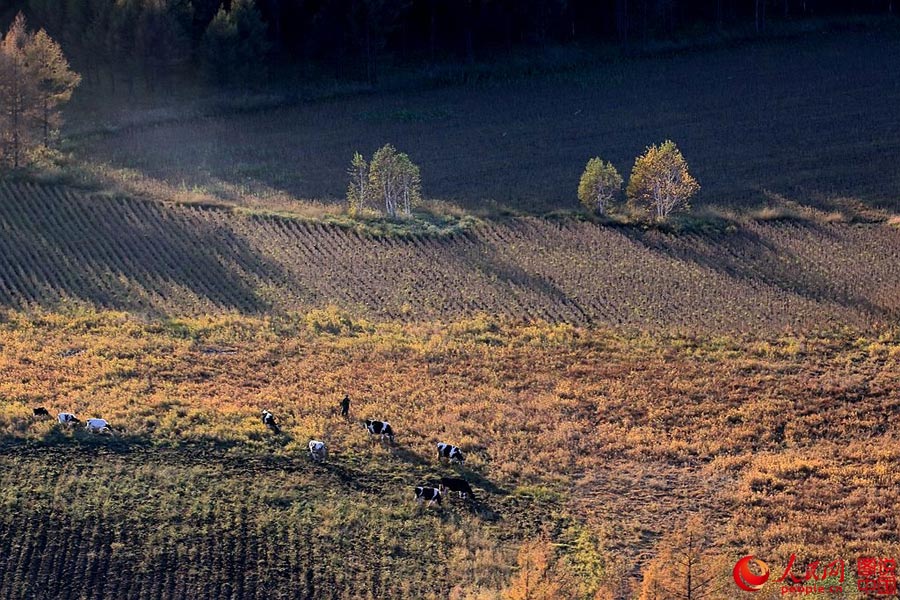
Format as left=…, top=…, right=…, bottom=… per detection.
left=0, top=445, right=536, bottom=600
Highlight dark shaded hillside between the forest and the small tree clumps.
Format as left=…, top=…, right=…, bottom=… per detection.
left=72, top=31, right=900, bottom=212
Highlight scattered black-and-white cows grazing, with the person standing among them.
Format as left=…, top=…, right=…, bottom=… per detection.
left=33, top=404, right=475, bottom=506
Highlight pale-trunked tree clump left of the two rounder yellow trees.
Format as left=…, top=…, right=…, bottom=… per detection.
left=347, top=144, right=422, bottom=217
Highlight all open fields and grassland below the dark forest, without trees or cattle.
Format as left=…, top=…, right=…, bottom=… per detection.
left=0, top=30, right=900, bottom=600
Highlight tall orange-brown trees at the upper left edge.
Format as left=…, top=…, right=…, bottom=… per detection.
left=0, top=13, right=81, bottom=168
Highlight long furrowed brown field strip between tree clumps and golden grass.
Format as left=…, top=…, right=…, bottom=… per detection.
left=0, top=183, right=900, bottom=331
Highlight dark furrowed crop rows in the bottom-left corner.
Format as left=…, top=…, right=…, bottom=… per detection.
left=0, top=506, right=464, bottom=600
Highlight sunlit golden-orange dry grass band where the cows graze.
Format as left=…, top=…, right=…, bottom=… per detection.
left=0, top=311, right=900, bottom=598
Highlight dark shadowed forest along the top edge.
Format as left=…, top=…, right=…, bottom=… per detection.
left=0, top=0, right=894, bottom=87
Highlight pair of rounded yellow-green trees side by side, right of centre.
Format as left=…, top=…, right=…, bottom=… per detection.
left=578, top=140, right=700, bottom=221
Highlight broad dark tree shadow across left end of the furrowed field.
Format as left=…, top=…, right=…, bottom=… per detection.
left=0, top=184, right=298, bottom=314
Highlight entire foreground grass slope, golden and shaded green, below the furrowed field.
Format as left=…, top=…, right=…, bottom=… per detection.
left=0, top=312, right=900, bottom=599
